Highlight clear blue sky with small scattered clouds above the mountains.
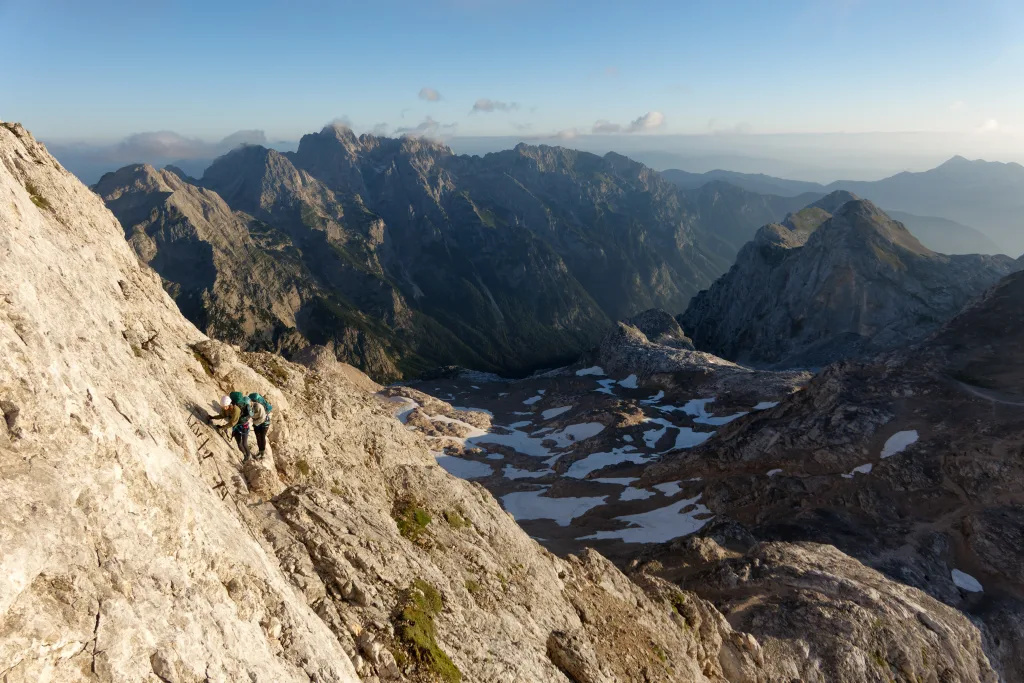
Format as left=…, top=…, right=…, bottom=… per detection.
left=0, top=0, right=1024, bottom=180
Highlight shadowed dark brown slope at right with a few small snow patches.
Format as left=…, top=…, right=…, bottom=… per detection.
left=641, top=272, right=1024, bottom=681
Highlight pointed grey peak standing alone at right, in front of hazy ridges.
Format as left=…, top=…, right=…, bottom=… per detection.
left=680, top=193, right=1017, bottom=367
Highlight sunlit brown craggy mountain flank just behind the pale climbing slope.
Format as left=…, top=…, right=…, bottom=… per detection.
left=93, top=161, right=417, bottom=380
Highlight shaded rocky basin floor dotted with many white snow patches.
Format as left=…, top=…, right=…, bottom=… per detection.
left=384, top=366, right=775, bottom=561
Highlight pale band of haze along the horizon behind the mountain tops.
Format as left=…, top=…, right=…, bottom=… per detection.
left=36, top=129, right=1024, bottom=184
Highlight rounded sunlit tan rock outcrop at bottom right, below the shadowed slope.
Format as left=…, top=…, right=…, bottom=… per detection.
left=634, top=538, right=999, bottom=683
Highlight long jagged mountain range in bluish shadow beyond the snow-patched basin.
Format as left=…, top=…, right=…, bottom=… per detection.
left=97, top=126, right=753, bottom=379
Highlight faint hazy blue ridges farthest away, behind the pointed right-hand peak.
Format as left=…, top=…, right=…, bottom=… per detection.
left=663, top=157, right=1024, bottom=256
